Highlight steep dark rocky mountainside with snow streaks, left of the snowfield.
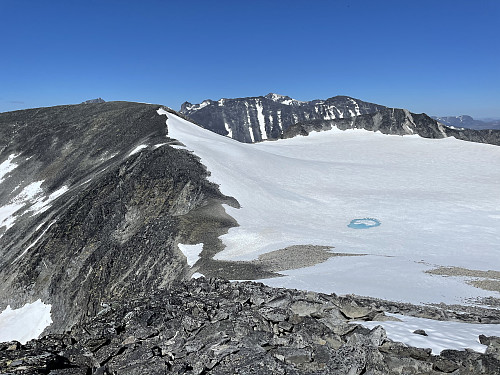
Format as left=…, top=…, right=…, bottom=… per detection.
left=0, top=102, right=235, bottom=331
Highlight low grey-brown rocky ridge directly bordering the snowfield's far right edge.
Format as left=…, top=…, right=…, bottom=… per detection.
left=282, top=108, right=500, bottom=145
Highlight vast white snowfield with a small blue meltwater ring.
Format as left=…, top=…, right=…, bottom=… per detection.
left=161, top=114, right=500, bottom=303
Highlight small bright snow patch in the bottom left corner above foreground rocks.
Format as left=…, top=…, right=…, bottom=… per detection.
left=0, top=300, right=52, bottom=345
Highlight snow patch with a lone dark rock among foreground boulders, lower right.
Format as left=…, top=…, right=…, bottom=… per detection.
left=354, top=314, right=500, bottom=355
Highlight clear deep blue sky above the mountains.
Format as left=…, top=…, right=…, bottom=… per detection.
left=0, top=0, right=500, bottom=118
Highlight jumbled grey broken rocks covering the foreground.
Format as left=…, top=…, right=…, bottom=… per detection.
left=0, top=278, right=500, bottom=375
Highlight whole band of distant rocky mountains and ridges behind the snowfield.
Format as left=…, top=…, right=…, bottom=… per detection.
left=180, top=93, right=500, bottom=145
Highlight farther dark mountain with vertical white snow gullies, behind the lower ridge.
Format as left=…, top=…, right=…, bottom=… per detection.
left=180, top=93, right=385, bottom=143
